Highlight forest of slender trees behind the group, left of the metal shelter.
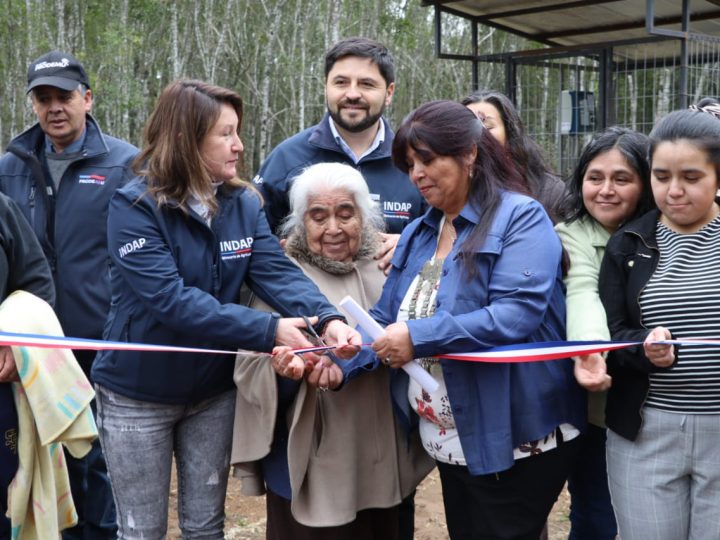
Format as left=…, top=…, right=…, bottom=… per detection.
left=0, top=0, right=522, bottom=178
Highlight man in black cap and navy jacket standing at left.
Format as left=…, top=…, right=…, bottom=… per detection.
left=0, top=51, right=137, bottom=539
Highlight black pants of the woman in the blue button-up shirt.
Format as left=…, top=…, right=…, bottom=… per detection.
left=438, top=439, right=579, bottom=540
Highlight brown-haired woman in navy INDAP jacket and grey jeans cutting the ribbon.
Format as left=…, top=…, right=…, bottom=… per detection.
left=93, top=80, right=360, bottom=538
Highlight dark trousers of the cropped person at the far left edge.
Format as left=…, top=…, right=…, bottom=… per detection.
left=0, top=383, right=18, bottom=540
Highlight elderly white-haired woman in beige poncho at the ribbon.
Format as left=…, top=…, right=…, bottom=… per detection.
left=232, top=163, right=433, bottom=539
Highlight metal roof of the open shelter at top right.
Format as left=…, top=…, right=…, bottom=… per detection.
left=422, top=0, right=720, bottom=54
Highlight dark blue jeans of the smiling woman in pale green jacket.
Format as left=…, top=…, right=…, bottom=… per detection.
left=568, top=424, right=617, bottom=540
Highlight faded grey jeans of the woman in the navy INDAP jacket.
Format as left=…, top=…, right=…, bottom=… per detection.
left=96, top=386, right=235, bottom=540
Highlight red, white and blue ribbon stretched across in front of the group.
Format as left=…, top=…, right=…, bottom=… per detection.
left=0, top=332, right=720, bottom=363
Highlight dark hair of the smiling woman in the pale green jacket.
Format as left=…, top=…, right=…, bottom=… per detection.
left=563, top=126, right=655, bottom=223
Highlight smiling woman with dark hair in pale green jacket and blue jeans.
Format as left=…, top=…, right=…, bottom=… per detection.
left=555, top=127, right=654, bottom=540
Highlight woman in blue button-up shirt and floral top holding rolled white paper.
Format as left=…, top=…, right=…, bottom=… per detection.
left=346, top=101, right=585, bottom=539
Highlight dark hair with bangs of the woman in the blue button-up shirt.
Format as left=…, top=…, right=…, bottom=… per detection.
left=392, top=101, right=527, bottom=278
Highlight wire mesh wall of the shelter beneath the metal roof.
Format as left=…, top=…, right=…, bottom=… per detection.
left=511, top=36, right=720, bottom=176
